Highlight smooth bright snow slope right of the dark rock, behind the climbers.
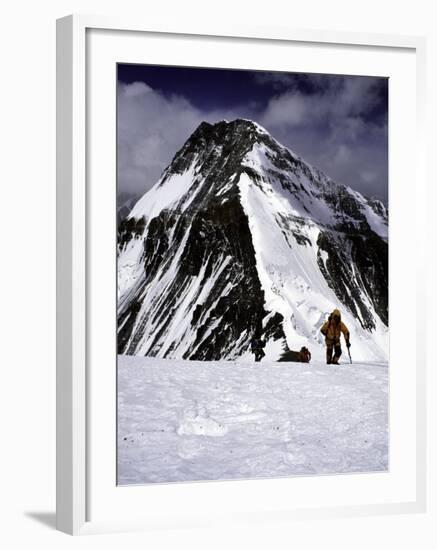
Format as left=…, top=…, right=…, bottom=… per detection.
left=238, top=145, right=388, bottom=361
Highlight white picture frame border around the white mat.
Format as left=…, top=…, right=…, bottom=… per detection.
left=56, top=15, right=427, bottom=535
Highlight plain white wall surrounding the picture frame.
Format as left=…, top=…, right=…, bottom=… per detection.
left=0, top=0, right=437, bottom=550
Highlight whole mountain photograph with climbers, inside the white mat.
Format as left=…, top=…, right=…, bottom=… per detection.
left=117, top=64, right=389, bottom=485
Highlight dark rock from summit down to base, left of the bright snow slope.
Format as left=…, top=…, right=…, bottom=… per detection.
left=118, top=121, right=283, bottom=360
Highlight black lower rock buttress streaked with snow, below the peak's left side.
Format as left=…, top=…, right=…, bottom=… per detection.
left=119, top=196, right=266, bottom=360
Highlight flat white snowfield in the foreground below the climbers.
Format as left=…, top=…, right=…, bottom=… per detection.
left=118, top=356, right=388, bottom=485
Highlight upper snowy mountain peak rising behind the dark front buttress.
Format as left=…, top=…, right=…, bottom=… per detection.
left=129, top=119, right=387, bottom=238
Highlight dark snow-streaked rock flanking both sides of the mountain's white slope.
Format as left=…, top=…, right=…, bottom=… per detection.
left=118, top=120, right=388, bottom=360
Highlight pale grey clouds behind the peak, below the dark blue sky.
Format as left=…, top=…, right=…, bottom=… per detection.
left=118, top=74, right=387, bottom=202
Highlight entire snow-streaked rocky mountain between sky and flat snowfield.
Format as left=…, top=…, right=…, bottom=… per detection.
left=118, top=119, right=388, bottom=360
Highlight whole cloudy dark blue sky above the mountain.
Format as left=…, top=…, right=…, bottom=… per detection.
left=117, top=64, right=388, bottom=202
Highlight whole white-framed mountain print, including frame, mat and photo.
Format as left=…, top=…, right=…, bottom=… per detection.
left=57, top=16, right=426, bottom=534
